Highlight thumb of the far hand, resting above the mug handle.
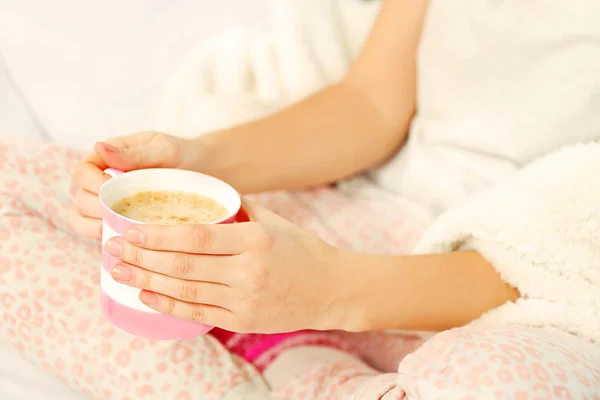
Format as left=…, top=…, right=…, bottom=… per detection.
left=94, top=142, right=164, bottom=171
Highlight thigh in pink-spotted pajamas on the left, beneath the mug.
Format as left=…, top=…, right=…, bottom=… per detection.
left=0, top=138, right=256, bottom=399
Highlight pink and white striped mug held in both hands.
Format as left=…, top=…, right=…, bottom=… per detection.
left=98, top=168, right=243, bottom=340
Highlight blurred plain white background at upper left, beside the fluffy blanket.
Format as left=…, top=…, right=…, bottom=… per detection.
left=0, top=0, right=267, bottom=147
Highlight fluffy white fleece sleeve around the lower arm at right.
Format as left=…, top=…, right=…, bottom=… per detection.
left=416, top=143, right=600, bottom=344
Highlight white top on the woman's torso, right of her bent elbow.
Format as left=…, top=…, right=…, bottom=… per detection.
left=372, top=0, right=600, bottom=212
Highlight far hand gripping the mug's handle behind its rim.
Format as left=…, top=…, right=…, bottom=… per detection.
left=67, top=132, right=200, bottom=239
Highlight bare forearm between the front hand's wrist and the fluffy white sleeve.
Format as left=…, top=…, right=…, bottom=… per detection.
left=332, top=251, right=519, bottom=331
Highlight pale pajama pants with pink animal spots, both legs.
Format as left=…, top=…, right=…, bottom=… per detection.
left=0, top=140, right=600, bottom=400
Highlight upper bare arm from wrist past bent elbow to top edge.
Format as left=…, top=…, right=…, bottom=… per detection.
left=198, top=0, right=427, bottom=192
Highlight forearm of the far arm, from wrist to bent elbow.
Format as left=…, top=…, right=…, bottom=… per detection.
left=198, top=82, right=412, bottom=193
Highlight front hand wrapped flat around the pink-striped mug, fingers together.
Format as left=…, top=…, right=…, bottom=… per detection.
left=105, top=200, right=349, bottom=333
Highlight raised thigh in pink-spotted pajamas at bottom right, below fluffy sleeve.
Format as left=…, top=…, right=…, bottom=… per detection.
left=397, top=326, right=600, bottom=400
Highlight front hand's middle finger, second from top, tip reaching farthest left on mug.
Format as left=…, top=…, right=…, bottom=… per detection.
left=105, top=237, right=234, bottom=285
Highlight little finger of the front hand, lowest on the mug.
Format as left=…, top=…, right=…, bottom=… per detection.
left=139, top=291, right=235, bottom=329
